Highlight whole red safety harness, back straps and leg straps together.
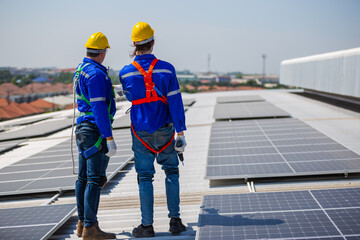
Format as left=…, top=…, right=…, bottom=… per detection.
left=131, top=58, right=175, bottom=155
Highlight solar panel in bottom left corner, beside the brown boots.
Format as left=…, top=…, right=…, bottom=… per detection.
left=0, top=204, right=76, bottom=240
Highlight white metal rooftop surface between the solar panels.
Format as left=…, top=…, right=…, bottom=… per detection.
left=0, top=90, right=360, bottom=239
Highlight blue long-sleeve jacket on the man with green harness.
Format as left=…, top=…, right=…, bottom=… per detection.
left=76, top=57, right=116, bottom=138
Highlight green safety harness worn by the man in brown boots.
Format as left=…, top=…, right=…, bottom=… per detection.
left=74, top=63, right=115, bottom=159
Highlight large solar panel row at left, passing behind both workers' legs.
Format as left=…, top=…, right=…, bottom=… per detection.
left=0, top=129, right=133, bottom=196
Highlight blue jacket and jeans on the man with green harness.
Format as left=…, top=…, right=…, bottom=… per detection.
left=74, top=58, right=116, bottom=228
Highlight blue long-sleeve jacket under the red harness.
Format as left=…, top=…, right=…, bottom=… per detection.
left=119, top=54, right=186, bottom=133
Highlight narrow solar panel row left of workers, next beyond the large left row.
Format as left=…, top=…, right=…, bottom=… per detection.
left=0, top=118, right=72, bottom=141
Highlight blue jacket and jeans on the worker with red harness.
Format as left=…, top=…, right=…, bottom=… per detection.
left=119, top=54, right=186, bottom=226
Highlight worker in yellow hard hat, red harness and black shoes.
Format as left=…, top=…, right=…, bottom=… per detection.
left=119, top=22, right=186, bottom=238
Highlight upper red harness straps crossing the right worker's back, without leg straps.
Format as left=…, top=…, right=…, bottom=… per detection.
left=131, top=58, right=167, bottom=105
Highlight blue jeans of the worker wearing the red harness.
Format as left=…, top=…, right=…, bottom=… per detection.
left=131, top=126, right=180, bottom=225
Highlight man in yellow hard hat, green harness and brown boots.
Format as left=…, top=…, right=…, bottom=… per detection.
left=74, top=32, right=116, bottom=239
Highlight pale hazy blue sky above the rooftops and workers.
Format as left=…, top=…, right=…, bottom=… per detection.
left=0, top=0, right=360, bottom=74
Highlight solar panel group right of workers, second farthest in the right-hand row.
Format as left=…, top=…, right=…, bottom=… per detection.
left=214, top=102, right=290, bottom=120
